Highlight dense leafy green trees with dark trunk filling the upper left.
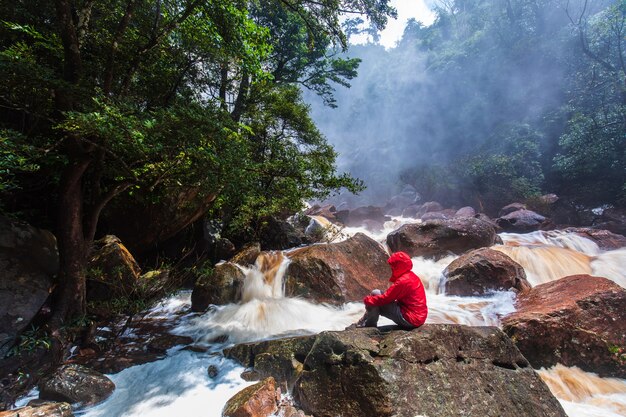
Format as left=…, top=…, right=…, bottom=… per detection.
left=0, top=0, right=394, bottom=317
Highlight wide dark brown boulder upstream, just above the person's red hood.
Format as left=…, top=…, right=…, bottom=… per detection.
left=387, top=218, right=496, bottom=258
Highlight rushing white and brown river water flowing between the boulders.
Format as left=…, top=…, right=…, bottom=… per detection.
left=24, top=218, right=626, bottom=417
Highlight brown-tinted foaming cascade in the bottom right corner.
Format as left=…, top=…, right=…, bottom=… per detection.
left=538, top=365, right=626, bottom=417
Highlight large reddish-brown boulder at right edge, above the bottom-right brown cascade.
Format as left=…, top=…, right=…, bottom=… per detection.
left=502, top=275, right=626, bottom=378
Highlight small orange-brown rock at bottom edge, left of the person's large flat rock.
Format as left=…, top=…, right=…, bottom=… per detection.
left=222, top=377, right=279, bottom=417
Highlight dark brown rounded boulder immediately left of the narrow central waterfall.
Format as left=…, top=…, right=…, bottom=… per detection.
left=191, top=262, right=246, bottom=311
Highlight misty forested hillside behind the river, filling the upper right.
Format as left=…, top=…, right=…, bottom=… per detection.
left=311, top=0, right=626, bottom=214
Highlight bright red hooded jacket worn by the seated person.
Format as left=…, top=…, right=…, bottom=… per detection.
left=363, top=252, right=428, bottom=327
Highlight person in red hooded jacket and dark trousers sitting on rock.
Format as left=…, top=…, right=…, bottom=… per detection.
left=357, top=252, right=428, bottom=329
